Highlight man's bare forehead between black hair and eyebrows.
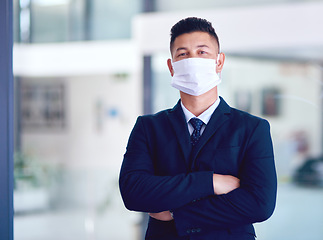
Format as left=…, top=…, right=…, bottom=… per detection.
left=171, top=32, right=217, bottom=52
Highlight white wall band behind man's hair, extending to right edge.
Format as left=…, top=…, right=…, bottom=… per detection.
left=133, top=2, right=323, bottom=61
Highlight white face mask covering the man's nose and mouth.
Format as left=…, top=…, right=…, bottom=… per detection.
left=171, top=55, right=221, bottom=96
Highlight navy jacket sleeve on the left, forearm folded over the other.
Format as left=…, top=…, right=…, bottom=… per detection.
left=119, top=117, right=214, bottom=213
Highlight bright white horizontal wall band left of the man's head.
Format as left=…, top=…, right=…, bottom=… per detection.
left=13, top=40, right=141, bottom=77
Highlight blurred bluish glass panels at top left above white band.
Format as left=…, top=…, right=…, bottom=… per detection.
left=14, top=0, right=142, bottom=43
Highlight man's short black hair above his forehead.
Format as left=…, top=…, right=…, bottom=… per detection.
left=170, top=17, right=220, bottom=51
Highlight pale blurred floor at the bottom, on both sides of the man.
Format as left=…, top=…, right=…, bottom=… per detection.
left=15, top=184, right=323, bottom=240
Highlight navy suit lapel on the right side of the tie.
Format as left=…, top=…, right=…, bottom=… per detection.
left=189, top=97, right=231, bottom=168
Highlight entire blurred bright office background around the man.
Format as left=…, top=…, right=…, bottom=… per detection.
left=13, top=0, right=323, bottom=240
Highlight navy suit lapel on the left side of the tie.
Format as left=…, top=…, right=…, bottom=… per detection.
left=168, top=101, right=192, bottom=166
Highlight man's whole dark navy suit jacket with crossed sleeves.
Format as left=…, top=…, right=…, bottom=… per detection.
left=119, top=98, right=277, bottom=240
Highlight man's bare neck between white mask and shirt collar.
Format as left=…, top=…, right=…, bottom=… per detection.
left=180, top=87, right=218, bottom=117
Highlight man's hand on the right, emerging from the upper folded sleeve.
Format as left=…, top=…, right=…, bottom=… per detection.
left=213, top=174, right=240, bottom=195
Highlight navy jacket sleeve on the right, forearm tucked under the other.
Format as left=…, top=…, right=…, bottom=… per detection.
left=173, top=120, right=277, bottom=235
